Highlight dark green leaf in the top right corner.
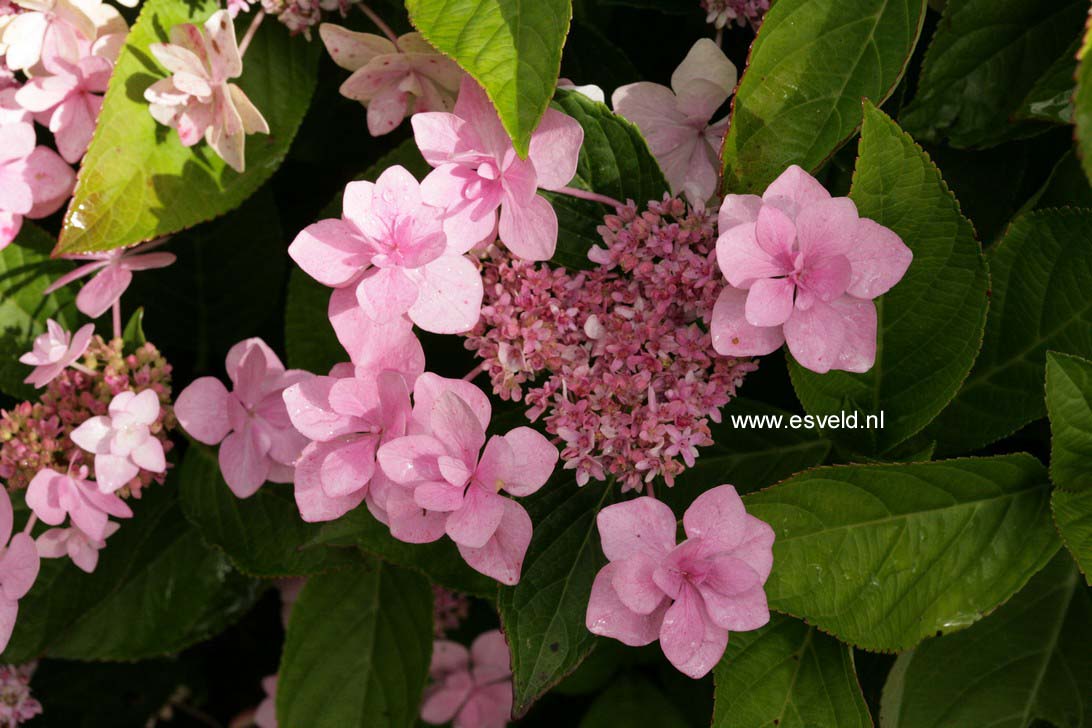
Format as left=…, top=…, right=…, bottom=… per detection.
left=901, top=0, right=1088, bottom=146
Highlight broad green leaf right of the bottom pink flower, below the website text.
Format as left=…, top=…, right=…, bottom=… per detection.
left=744, top=454, right=1058, bottom=651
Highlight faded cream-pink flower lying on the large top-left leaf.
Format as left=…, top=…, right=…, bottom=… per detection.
left=144, top=10, right=270, bottom=172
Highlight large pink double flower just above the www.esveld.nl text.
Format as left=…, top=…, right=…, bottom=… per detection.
left=710, top=165, right=913, bottom=372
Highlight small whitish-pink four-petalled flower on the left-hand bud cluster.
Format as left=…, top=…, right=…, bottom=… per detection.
left=69, top=390, right=167, bottom=493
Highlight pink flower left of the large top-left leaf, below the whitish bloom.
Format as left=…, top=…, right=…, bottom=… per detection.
left=15, top=38, right=114, bottom=163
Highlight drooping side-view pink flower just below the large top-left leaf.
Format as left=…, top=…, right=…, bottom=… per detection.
left=45, top=240, right=176, bottom=319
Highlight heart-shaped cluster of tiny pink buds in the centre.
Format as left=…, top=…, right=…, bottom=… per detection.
left=466, top=198, right=757, bottom=490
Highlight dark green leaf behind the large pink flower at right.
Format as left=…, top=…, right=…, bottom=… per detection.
left=790, top=104, right=989, bottom=453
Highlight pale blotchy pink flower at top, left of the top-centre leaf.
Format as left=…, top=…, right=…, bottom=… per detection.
left=319, top=23, right=464, bottom=136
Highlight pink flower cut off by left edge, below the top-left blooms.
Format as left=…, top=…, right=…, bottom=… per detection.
left=0, top=120, right=75, bottom=250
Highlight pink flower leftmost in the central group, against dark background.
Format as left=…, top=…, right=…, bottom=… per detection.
left=175, top=338, right=311, bottom=498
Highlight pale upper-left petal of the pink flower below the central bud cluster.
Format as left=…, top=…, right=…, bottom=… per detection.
left=595, top=497, right=676, bottom=561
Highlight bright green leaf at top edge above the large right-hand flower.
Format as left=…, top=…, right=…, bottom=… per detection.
left=723, top=0, right=925, bottom=193
